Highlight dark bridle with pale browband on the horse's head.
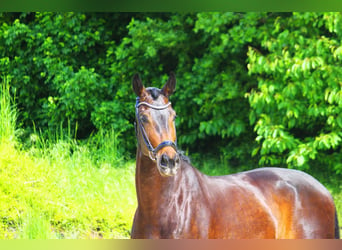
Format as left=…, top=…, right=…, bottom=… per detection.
left=134, top=97, right=178, bottom=161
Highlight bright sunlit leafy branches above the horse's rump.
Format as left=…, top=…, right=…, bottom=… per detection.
left=248, top=13, right=342, bottom=173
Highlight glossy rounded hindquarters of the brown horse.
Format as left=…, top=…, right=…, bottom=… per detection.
left=232, top=168, right=335, bottom=238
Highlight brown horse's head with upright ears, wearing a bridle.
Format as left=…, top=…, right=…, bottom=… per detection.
left=133, top=73, right=180, bottom=176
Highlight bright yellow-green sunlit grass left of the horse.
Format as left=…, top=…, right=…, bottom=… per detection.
left=0, top=79, right=136, bottom=239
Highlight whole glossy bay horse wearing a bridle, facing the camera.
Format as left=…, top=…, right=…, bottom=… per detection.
left=131, top=73, right=339, bottom=239
